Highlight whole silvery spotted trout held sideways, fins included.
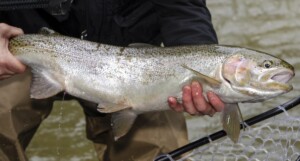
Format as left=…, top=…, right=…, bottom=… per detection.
left=9, top=29, right=295, bottom=143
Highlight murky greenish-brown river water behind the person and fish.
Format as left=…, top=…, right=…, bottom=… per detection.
left=27, top=0, right=300, bottom=161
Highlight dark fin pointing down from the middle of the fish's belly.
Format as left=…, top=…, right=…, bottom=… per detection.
left=111, top=109, right=137, bottom=140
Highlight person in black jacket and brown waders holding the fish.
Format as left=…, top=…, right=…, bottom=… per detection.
left=0, top=0, right=224, bottom=161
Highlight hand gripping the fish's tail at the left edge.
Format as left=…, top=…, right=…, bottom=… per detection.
left=0, top=23, right=26, bottom=80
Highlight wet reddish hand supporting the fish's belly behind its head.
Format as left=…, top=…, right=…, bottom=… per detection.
left=168, top=81, right=225, bottom=116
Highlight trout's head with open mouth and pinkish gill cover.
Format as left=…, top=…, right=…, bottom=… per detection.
left=222, top=49, right=295, bottom=102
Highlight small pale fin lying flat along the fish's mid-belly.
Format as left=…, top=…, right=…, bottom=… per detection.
left=97, top=103, right=131, bottom=113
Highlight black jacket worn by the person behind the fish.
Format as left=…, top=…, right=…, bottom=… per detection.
left=0, top=0, right=217, bottom=46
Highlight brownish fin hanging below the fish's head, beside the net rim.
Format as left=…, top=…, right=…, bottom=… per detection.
left=221, top=104, right=240, bottom=143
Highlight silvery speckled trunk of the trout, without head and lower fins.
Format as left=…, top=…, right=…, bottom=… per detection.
left=10, top=35, right=230, bottom=111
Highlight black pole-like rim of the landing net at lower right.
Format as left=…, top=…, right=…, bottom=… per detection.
left=154, top=96, right=300, bottom=161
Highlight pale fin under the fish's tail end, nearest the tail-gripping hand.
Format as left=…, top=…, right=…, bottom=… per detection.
left=30, top=69, right=63, bottom=99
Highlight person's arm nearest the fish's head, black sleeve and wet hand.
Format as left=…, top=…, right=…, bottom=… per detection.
left=153, top=0, right=224, bottom=116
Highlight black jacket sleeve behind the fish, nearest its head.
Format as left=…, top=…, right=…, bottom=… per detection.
left=152, top=0, right=218, bottom=46
